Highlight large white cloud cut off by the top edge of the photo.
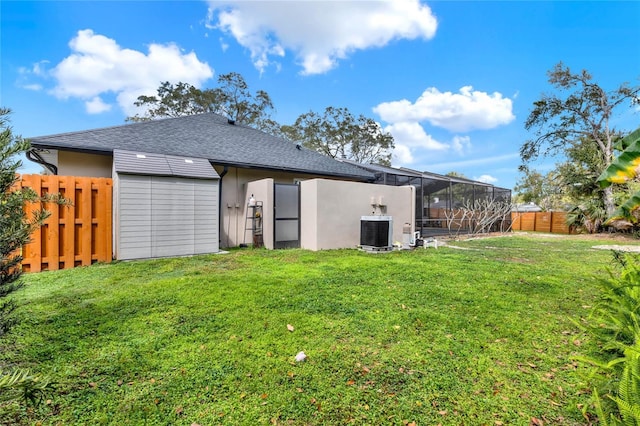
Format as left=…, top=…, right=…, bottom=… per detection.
left=207, top=0, right=438, bottom=74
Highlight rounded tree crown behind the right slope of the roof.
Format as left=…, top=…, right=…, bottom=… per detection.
left=282, top=107, right=394, bottom=166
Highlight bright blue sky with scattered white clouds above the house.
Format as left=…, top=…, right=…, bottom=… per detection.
left=0, top=0, right=640, bottom=188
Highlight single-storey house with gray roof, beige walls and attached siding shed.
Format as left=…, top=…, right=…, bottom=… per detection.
left=28, top=113, right=415, bottom=259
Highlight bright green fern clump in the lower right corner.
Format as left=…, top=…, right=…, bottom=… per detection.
left=583, top=252, right=640, bottom=426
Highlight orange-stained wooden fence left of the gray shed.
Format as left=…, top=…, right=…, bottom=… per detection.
left=18, top=175, right=113, bottom=272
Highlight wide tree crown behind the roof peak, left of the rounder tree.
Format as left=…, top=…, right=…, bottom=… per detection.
left=127, top=72, right=279, bottom=131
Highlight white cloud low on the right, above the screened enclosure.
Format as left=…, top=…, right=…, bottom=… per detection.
left=373, top=86, right=515, bottom=132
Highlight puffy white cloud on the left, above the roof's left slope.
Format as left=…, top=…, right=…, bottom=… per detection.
left=51, top=30, right=213, bottom=115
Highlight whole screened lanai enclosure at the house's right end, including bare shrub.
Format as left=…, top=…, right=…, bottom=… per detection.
left=353, top=163, right=511, bottom=237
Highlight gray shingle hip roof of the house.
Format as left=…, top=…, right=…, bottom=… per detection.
left=29, top=113, right=374, bottom=180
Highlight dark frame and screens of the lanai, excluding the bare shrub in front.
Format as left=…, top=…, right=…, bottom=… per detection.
left=358, top=164, right=511, bottom=237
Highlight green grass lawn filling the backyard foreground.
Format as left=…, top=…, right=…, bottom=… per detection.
left=0, top=235, right=632, bottom=425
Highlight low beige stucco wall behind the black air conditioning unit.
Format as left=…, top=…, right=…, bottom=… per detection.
left=300, top=179, right=415, bottom=250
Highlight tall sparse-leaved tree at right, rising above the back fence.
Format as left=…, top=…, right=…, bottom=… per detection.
left=520, top=62, right=640, bottom=214
